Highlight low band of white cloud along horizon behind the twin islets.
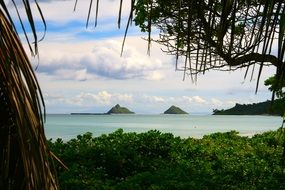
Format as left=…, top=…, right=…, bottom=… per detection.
left=41, top=87, right=272, bottom=113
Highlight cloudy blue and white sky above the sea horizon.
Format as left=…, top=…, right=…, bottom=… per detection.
left=11, top=0, right=274, bottom=114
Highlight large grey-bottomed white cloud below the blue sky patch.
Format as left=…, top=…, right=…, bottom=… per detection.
left=34, top=40, right=165, bottom=81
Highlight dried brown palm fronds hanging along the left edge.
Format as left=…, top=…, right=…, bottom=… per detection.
left=0, top=0, right=57, bottom=189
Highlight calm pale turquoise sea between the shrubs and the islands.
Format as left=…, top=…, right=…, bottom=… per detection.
left=45, top=114, right=282, bottom=140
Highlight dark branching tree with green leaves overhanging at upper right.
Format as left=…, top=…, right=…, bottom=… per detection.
left=130, top=0, right=285, bottom=93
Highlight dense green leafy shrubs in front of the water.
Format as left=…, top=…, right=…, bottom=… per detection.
left=49, top=129, right=285, bottom=190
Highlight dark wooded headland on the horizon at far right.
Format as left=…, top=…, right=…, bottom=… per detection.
left=213, top=99, right=285, bottom=115
